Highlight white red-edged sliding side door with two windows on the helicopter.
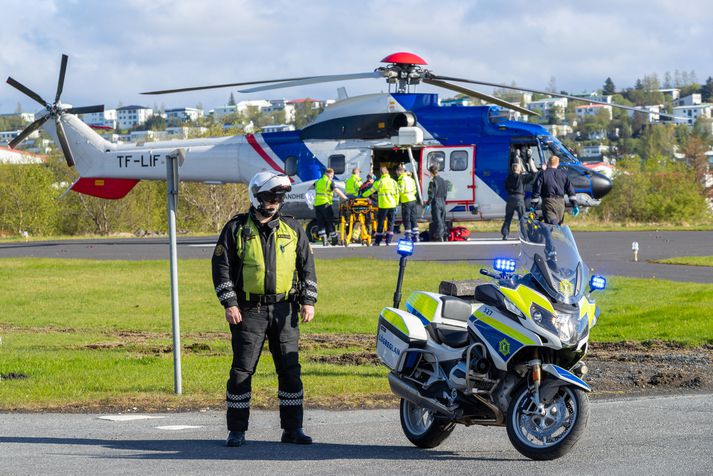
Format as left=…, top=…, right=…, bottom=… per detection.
left=420, top=145, right=475, bottom=212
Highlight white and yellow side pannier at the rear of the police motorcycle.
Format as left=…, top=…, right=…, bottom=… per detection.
left=376, top=307, right=428, bottom=372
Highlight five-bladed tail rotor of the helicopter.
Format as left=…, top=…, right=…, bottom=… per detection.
left=7, top=54, right=104, bottom=167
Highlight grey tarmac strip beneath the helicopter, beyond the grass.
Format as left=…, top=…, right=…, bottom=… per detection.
left=0, top=231, right=713, bottom=283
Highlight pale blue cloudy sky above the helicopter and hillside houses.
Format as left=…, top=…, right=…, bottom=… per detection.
left=0, top=0, right=713, bottom=112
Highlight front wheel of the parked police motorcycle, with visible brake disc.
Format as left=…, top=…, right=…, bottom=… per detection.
left=507, top=386, right=589, bottom=460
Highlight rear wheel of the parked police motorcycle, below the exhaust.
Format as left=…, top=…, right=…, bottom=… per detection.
left=399, top=398, right=455, bottom=448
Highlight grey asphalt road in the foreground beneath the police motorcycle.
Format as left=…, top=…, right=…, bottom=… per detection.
left=0, top=395, right=713, bottom=476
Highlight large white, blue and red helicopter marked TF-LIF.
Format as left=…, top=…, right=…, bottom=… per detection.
left=7, top=52, right=660, bottom=235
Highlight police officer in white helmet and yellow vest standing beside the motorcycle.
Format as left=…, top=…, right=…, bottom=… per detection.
left=212, top=172, right=317, bottom=446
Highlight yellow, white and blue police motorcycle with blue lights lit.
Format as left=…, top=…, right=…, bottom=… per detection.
left=377, top=215, right=606, bottom=460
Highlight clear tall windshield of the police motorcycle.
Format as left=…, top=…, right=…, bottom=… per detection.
left=519, top=218, right=589, bottom=304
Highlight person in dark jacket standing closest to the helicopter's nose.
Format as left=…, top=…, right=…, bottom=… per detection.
left=530, top=155, right=579, bottom=225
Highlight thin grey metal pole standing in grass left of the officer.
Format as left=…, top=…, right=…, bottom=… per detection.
left=166, top=154, right=183, bottom=395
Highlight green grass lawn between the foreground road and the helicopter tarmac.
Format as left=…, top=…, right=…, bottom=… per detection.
left=0, top=257, right=713, bottom=410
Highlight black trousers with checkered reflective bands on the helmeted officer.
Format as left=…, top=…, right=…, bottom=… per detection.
left=226, top=302, right=303, bottom=431
